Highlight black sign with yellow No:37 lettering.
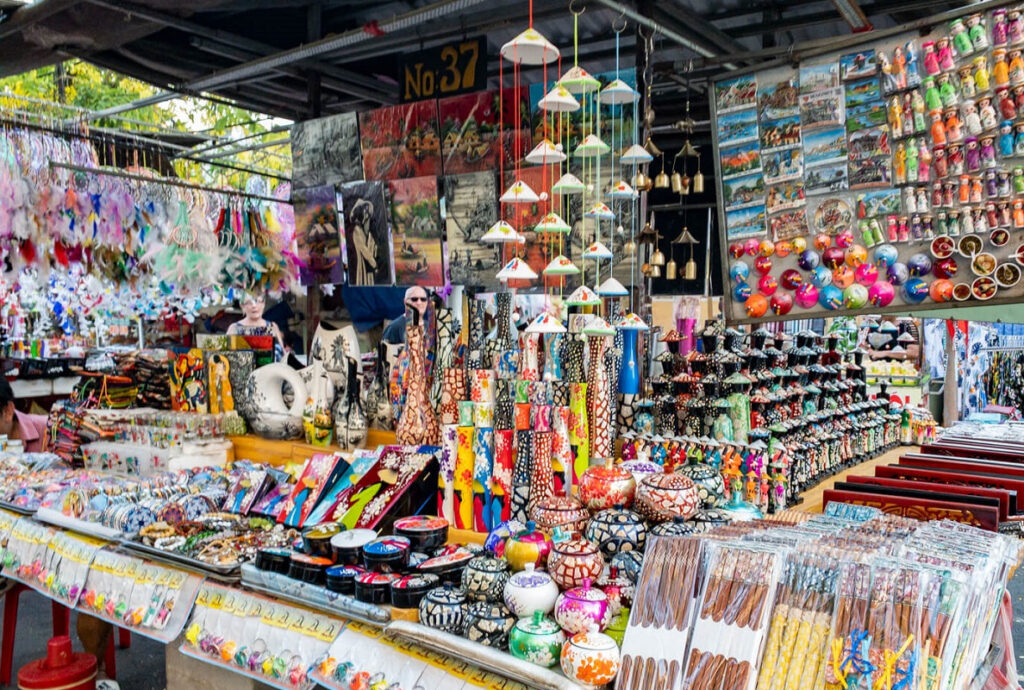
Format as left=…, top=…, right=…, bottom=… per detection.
left=398, top=36, right=487, bottom=102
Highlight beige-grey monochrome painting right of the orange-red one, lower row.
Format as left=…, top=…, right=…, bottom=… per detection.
left=442, top=172, right=502, bottom=287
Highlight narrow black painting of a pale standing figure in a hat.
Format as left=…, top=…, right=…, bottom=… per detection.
left=341, top=180, right=394, bottom=286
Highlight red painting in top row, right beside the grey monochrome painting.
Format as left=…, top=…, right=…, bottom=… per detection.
left=359, top=100, right=441, bottom=180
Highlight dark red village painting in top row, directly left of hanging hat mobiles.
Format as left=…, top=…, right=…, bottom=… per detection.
left=438, top=89, right=531, bottom=175
